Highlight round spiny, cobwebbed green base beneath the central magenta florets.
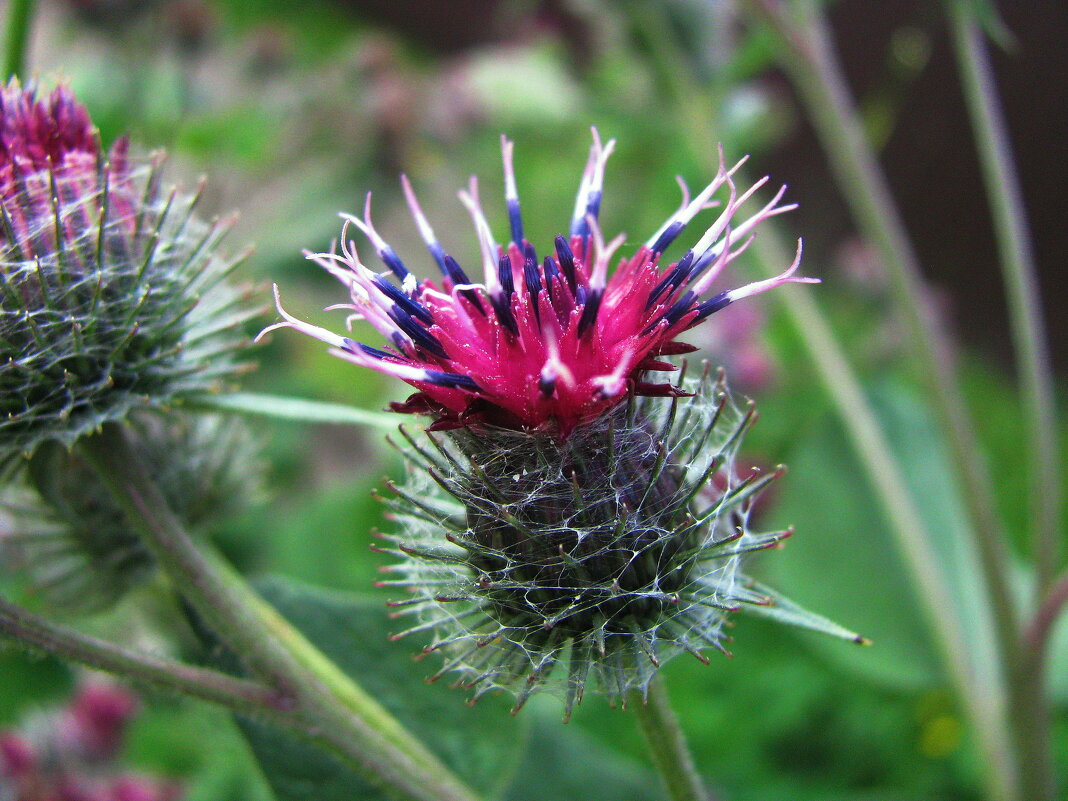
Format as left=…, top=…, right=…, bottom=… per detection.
left=383, top=372, right=788, bottom=714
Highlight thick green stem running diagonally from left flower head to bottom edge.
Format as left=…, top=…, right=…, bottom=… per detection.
left=80, top=424, right=475, bottom=801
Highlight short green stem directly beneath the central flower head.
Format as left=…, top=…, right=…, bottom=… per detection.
left=630, top=673, right=711, bottom=801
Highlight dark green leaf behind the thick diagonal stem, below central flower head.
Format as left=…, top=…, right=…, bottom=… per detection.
left=231, top=578, right=529, bottom=801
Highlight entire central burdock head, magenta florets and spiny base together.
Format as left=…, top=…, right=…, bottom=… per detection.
left=268, top=131, right=853, bottom=714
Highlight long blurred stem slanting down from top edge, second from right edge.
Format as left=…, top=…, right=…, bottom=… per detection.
left=743, top=0, right=1017, bottom=679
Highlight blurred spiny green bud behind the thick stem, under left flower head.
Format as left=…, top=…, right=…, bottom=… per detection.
left=0, top=411, right=263, bottom=612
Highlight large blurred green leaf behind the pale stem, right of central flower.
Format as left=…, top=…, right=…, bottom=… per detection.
left=759, top=383, right=1000, bottom=690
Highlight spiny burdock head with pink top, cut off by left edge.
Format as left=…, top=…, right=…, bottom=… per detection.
left=0, top=81, right=251, bottom=460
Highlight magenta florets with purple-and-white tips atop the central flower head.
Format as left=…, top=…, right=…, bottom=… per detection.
left=265, top=129, right=817, bottom=436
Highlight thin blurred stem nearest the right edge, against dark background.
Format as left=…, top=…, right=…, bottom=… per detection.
left=947, top=0, right=1061, bottom=597
